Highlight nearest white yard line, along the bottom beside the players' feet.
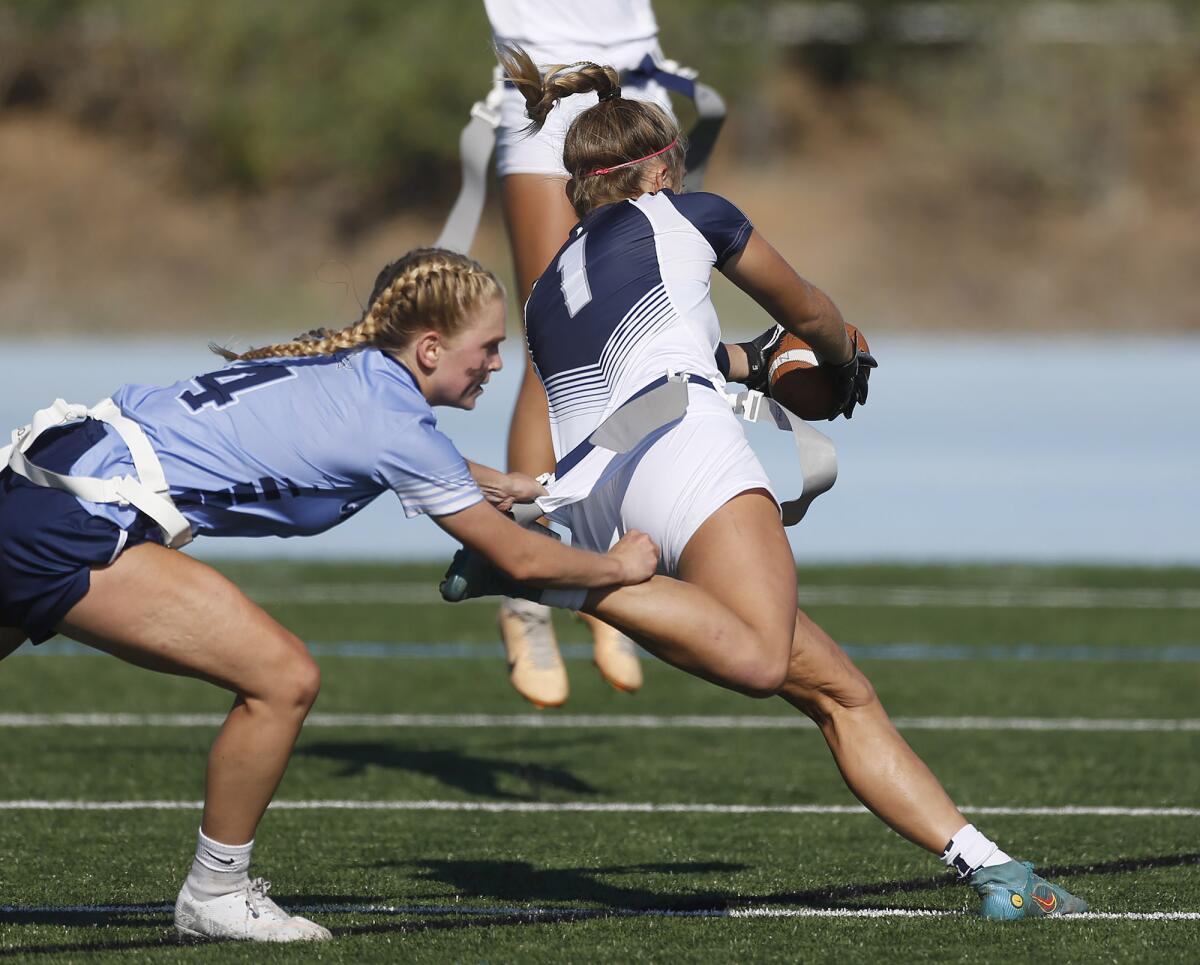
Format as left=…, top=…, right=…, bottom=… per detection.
left=0, top=900, right=1200, bottom=922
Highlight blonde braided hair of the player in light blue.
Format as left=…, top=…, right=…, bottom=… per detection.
left=210, top=248, right=504, bottom=361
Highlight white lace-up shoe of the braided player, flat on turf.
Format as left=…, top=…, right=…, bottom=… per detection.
left=175, top=877, right=334, bottom=941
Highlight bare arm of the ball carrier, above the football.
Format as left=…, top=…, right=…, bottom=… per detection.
left=721, top=232, right=854, bottom=365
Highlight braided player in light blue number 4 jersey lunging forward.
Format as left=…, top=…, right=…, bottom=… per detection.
left=0, top=250, right=658, bottom=941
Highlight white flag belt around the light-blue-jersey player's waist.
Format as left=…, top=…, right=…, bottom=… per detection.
left=0, top=398, right=192, bottom=550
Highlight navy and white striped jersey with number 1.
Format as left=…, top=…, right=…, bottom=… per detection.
left=526, top=190, right=752, bottom=460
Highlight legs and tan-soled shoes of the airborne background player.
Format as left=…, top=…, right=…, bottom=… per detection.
left=500, top=174, right=642, bottom=706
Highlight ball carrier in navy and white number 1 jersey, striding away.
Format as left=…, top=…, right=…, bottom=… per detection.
left=458, top=48, right=1086, bottom=918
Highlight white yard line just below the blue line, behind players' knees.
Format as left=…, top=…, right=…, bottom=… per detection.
left=0, top=714, right=1200, bottom=733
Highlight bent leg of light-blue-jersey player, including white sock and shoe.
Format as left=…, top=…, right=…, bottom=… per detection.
left=58, top=544, right=330, bottom=941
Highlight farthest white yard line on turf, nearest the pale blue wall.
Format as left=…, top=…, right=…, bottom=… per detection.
left=238, top=582, right=1200, bottom=610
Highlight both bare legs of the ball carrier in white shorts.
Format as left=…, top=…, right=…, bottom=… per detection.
left=588, top=491, right=967, bottom=855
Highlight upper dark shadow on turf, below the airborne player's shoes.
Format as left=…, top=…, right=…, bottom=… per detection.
left=295, top=742, right=596, bottom=801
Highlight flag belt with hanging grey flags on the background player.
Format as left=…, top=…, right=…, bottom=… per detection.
left=434, top=54, right=725, bottom=254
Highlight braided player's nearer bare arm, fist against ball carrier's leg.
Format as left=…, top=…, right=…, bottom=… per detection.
left=433, top=502, right=659, bottom=589
